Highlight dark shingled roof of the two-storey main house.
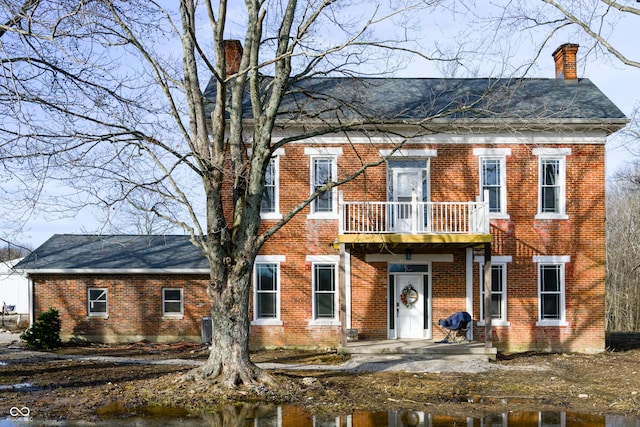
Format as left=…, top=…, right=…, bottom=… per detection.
left=204, top=77, right=627, bottom=127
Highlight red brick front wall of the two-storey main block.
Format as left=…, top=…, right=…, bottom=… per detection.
left=252, top=144, right=605, bottom=351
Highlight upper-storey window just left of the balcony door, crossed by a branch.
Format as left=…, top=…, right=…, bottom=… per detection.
left=305, top=148, right=342, bottom=219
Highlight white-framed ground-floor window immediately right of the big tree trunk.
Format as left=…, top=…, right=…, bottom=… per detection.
left=253, top=255, right=285, bottom=325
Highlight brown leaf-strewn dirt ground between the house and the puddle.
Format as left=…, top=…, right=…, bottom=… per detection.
left=0, top=334, right=640, bottom=420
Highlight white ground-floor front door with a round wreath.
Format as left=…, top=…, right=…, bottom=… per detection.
left=395, top=274, right=425, bottom=338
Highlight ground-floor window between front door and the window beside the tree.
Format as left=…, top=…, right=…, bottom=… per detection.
left=307, top=255, right=339, bottom=325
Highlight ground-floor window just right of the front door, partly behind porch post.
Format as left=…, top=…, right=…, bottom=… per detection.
left=476, top=256, right=511, bottom=326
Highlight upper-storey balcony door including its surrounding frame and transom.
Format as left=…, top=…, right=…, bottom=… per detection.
left=388, top=160, right=428, bottom=233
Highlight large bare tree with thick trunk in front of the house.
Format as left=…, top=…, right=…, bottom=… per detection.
left=0, top=0, right=476, bottom=386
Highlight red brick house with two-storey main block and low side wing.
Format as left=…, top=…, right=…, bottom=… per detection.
left=17, top=44, right=627, bottom=352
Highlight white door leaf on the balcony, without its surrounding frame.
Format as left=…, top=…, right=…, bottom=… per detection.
left=393, top=169, right=423, bottom=232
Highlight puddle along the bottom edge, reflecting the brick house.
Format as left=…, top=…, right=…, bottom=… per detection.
left=0, top=403, right=640, bottom=427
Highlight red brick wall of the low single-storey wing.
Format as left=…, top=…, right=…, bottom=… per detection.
left=32, top=274, right=211, bottom=342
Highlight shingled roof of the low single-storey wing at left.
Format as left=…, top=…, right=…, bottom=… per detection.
left=14, top=234, right=209, bottom=274
